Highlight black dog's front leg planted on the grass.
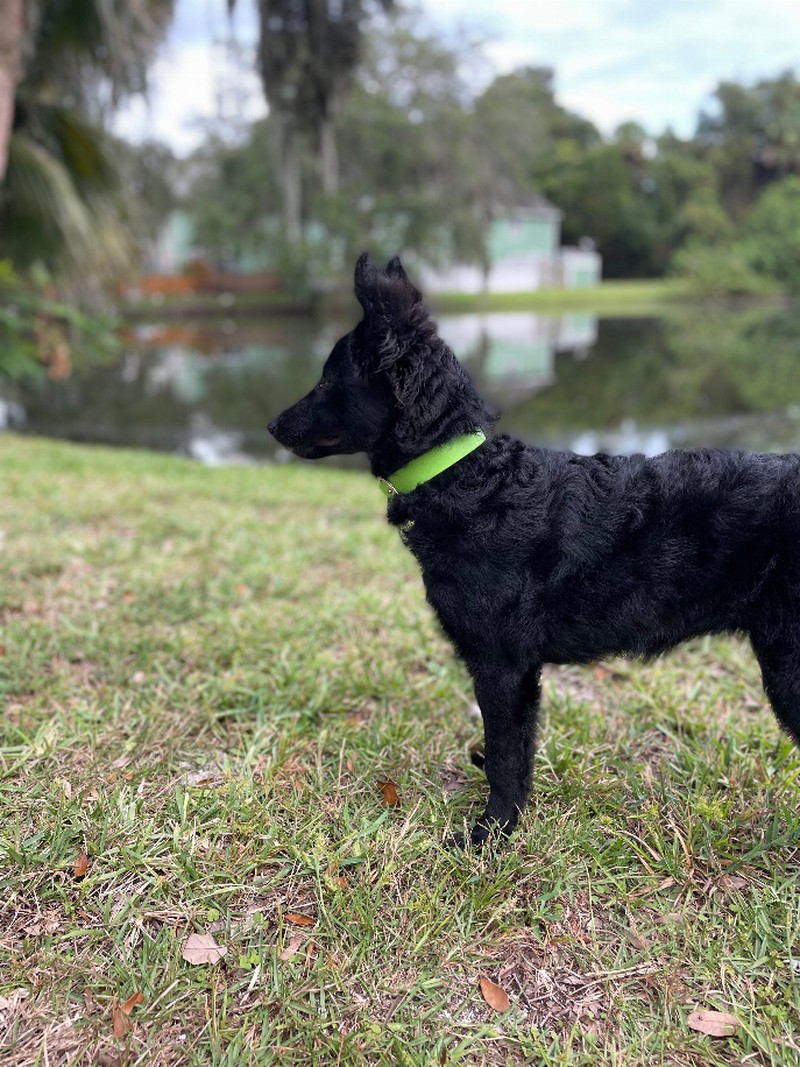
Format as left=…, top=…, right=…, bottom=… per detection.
left=460, top=663, right=542, bottom=847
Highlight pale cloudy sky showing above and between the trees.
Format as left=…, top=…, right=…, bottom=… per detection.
left=117, top=0, right=800, bottom=154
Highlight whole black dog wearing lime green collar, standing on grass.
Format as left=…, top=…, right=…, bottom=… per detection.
left=270, top=255, right=800, bottom=845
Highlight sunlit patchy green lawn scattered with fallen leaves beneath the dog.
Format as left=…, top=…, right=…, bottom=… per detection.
left=0, top=436, right=800, bottom=1067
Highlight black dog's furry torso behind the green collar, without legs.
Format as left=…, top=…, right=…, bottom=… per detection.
left=389, top=437, right=800, bottom=663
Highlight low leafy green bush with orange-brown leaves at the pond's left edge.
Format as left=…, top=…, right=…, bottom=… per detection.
left=0, top=260, right=118, bottom=382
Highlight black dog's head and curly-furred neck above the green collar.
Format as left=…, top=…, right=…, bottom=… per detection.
left=269, top=254, right=492, bottom=467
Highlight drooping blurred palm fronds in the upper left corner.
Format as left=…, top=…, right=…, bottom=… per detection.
left=0, top=0, right=174, bottom=277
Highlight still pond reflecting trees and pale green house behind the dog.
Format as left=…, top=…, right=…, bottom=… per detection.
left=0, top=306, right=800, bottom=464
